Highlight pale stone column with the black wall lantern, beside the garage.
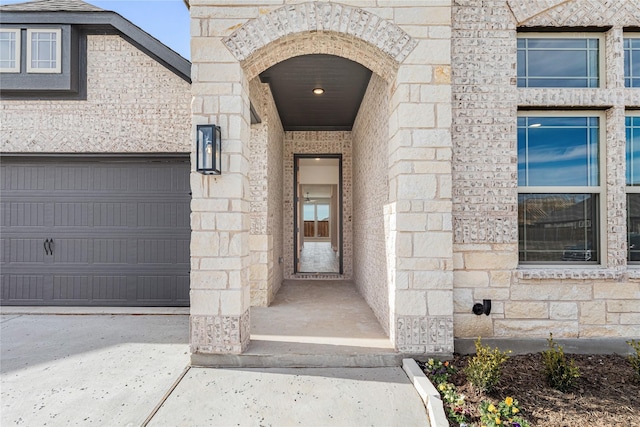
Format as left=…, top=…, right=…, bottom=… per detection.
left=191, top=4, right=250, bottom=354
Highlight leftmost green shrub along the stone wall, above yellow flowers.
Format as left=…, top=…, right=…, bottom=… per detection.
left=464, top=337, right=511, bottom=393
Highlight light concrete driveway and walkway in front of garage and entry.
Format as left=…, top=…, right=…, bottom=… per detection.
left=0, top=314, right=428, bottom=427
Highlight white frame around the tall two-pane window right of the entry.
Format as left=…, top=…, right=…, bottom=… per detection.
left=518, top=110, right=608, bottom=269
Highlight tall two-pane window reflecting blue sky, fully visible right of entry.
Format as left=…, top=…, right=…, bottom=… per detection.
left=518, top=112, right=605, bottom=265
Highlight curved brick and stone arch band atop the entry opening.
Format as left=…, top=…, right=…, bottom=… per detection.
left=223, top=2, right=417, bottom=80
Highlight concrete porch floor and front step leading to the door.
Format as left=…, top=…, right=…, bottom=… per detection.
left=191, top=280, right=406, bottom=367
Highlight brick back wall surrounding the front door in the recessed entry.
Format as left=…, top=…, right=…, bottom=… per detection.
left=283, top=131, right=353, bottom=280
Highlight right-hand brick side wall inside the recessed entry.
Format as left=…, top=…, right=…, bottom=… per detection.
left=352, top=74, right=395, bottom=334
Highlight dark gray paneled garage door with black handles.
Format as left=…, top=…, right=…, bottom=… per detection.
left=0, top=157, right=190, bottom=306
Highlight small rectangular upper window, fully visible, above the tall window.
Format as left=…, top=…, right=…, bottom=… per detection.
left=518, top=35, right=601, bottom=87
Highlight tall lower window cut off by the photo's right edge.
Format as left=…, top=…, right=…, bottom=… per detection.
left=625, top=114, right=640, bottom=263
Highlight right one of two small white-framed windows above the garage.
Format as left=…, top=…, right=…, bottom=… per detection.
left=27, top=29, right=62, bottom=73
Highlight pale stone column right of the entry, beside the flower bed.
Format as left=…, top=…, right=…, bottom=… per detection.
left=387, top=6, right=453, bottom=353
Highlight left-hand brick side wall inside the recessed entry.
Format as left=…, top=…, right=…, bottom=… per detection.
left=249, top=78, right=284, bottom=306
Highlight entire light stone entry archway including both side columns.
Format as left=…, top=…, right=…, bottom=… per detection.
left=191, top=2, right=453, bottom=353
